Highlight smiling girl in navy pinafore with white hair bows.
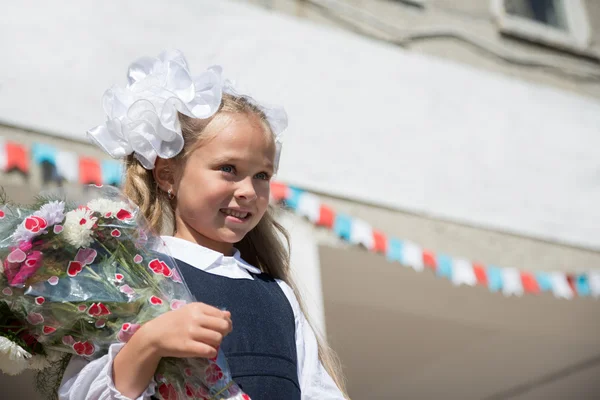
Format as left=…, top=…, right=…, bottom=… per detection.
left=59, top=51, right=345, bottom=400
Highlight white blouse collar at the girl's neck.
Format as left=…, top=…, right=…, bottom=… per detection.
left=161, top=236, right=261, bottom=274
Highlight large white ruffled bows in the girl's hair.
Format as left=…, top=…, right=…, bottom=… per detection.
left=87, top=50, right=287, bottom=169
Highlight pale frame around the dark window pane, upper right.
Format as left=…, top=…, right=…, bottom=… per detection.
left=491, top=0, right=592, bottom=52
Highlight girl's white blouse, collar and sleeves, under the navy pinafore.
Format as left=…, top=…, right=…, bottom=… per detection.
left=58, top=236, right=344, bottom=400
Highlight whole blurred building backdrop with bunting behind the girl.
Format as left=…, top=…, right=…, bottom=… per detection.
left=0, top=0, right=600, bottom=400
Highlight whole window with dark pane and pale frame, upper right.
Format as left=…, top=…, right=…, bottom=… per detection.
left=492, top=0, right=590, bottom=52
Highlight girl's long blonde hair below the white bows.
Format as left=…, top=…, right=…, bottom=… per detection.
left=124, top=94, right=349, bottom=398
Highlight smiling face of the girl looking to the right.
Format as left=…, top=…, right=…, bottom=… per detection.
left=174, top=114, right=275, bottom=254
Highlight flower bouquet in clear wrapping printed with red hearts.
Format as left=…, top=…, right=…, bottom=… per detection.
left=0, top=186, right=249, bottom=400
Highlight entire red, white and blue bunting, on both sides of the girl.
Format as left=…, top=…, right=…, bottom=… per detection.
left=0, top=137, right=600, bottom=299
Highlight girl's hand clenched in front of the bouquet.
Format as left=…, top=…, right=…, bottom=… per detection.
left=142, top=303, right=232, bottom=358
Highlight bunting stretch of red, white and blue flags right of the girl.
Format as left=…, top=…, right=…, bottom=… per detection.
left=271, top=182, right=600, bottom=299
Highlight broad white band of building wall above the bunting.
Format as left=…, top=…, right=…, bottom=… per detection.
left=0, top=0, right=600, bottom=249
